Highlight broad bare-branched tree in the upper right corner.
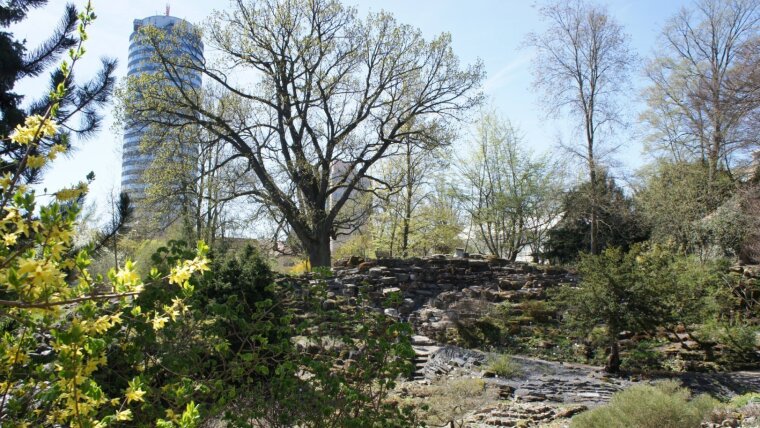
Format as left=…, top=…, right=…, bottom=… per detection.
left=642, top=0, right=760, bottom=187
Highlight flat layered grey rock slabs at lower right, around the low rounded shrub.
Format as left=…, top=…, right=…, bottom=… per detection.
left=417, top=346, right=760, bottom=428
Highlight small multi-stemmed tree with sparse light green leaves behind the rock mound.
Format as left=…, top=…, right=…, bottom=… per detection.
left=457, top=113, right=562, bottom=261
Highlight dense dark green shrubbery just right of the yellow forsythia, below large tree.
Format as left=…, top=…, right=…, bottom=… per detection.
left=101, top=241, right=414, bottom=427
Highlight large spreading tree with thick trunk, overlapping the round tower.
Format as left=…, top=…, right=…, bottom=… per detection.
left=122, top=0, right=483, bottom=266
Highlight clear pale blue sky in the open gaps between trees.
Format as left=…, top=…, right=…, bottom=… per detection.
left=10, top=0, right=690, bottom=219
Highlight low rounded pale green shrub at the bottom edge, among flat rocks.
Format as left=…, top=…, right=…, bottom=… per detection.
left=571, top=381, right=719, bottom=428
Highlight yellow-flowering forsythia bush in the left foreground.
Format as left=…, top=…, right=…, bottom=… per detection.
left=0, top=3, right=208, bottom=427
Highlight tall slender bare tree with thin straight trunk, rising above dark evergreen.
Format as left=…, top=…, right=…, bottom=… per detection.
left=526, top=0, right=636, bottom=254
